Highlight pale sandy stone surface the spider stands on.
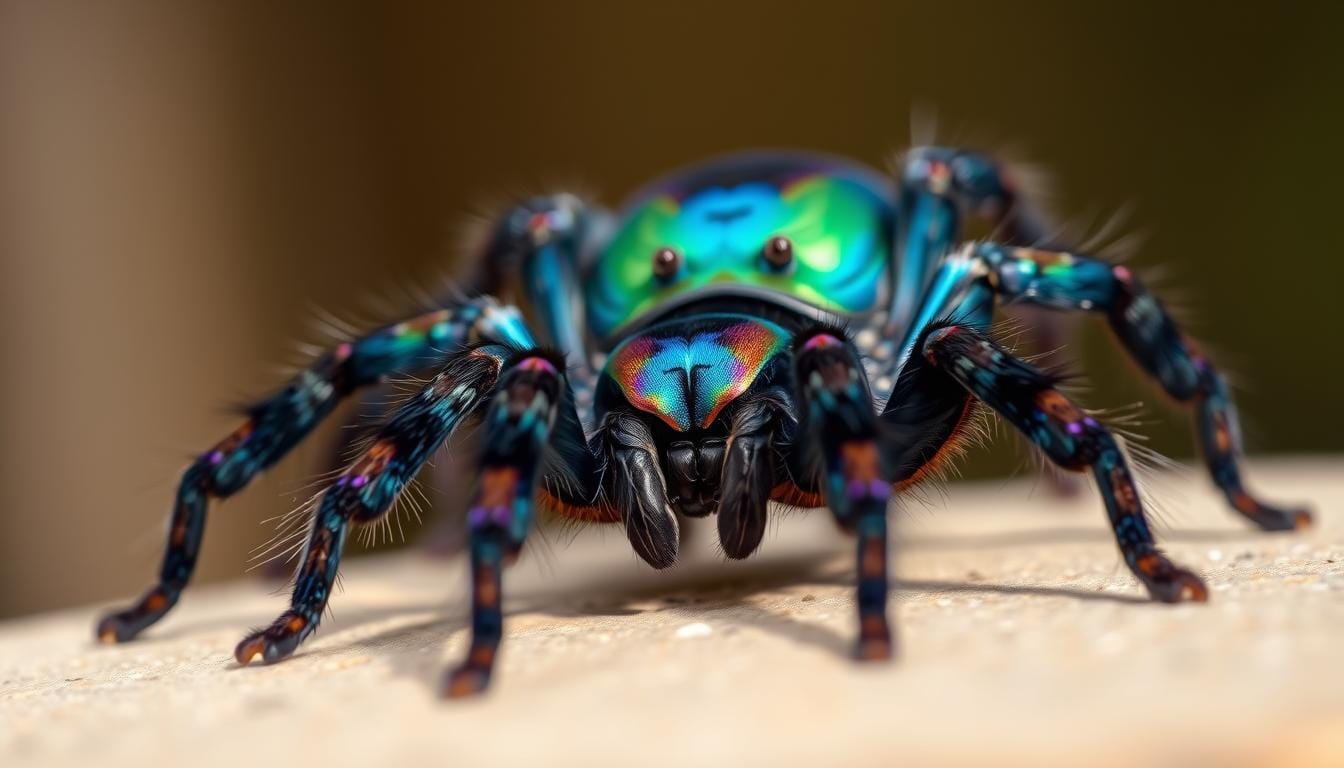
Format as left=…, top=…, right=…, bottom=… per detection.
left=0, top=459, right=1344, bottom=765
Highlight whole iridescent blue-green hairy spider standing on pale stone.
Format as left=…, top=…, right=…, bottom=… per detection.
left=97, top=147, right=1310, bottom=697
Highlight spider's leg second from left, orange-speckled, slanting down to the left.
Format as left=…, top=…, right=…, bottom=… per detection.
left=234, top=344, right=509, bottom=664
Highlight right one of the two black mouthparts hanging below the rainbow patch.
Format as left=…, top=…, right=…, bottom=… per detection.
left=719, top=391, right=789, bottom=560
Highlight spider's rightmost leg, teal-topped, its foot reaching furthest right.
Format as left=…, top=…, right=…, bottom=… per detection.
left=973, top=243, right=1312, bottom=530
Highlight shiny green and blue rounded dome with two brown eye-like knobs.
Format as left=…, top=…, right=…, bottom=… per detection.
left=583, top=153, right=892, bottom=340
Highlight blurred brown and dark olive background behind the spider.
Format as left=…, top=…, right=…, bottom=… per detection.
left=0, top=0, right=1344, bottom=615
